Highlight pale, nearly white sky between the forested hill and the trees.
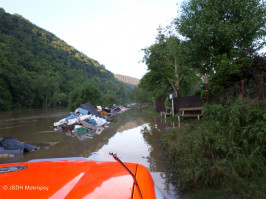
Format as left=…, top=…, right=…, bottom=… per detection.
left=0, top=0, right=182, bottom=78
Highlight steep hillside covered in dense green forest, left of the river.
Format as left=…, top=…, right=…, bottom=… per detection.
left=0, top=8, right=132, bottom=110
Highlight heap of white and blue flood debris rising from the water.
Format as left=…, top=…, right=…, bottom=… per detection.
left=54, top=103, right=128, bottom=140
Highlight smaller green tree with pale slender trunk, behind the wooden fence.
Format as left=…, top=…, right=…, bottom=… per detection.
left=140, top=28, right=200, bottom=96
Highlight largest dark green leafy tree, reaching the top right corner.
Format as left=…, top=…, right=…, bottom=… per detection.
left=175, top=0, right=266, bottom=98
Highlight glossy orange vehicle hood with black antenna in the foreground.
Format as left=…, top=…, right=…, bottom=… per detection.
left=0, top=153, right=163, bottom=199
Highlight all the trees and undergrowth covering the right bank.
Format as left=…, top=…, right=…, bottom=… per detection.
left=138, top=0, right=266, bottom=198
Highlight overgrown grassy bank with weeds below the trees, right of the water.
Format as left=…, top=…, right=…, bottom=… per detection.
left=163, top=101, right=266, bottom=198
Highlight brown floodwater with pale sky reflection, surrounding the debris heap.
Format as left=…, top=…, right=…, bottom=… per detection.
left=0, top=109, right=179, bottom=199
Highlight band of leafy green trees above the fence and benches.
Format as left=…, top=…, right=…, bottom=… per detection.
left=140, top=0, right=266, bottom=103
